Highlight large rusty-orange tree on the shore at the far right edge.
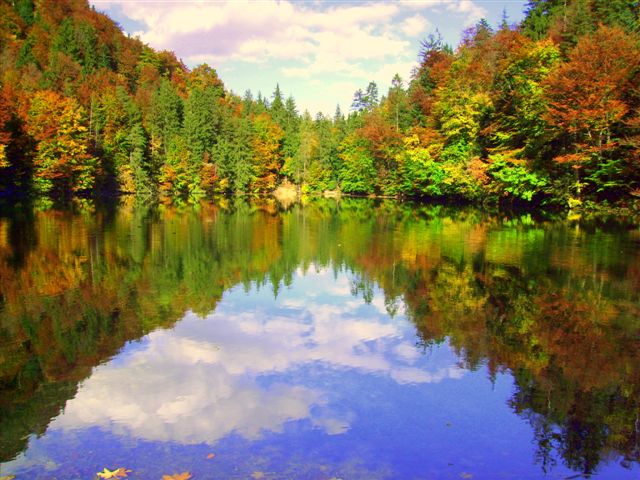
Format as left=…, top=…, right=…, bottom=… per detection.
left=545, top=27, right=640, bottom=195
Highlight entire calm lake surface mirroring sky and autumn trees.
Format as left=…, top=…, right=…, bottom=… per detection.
left=0, top=199, right=640, bottom=480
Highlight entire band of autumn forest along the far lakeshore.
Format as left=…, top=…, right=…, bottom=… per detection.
left=0, top=0, right=640, bottom=207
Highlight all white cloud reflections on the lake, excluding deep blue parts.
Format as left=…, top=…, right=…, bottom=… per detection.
left=52, top=273, right=463, bottom=443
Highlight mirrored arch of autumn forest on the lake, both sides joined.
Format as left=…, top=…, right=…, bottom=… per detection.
left=0, top=199, right=640, bottom=473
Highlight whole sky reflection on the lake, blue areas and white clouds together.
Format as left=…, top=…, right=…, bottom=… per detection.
left=0, top=269, right=637, bottom=480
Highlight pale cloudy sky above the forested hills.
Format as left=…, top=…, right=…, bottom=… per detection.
left=90, top=0, right=525, bottom=114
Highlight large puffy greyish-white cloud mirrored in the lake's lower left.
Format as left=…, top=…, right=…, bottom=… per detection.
left=52, top=331, right=323, bottom=443
